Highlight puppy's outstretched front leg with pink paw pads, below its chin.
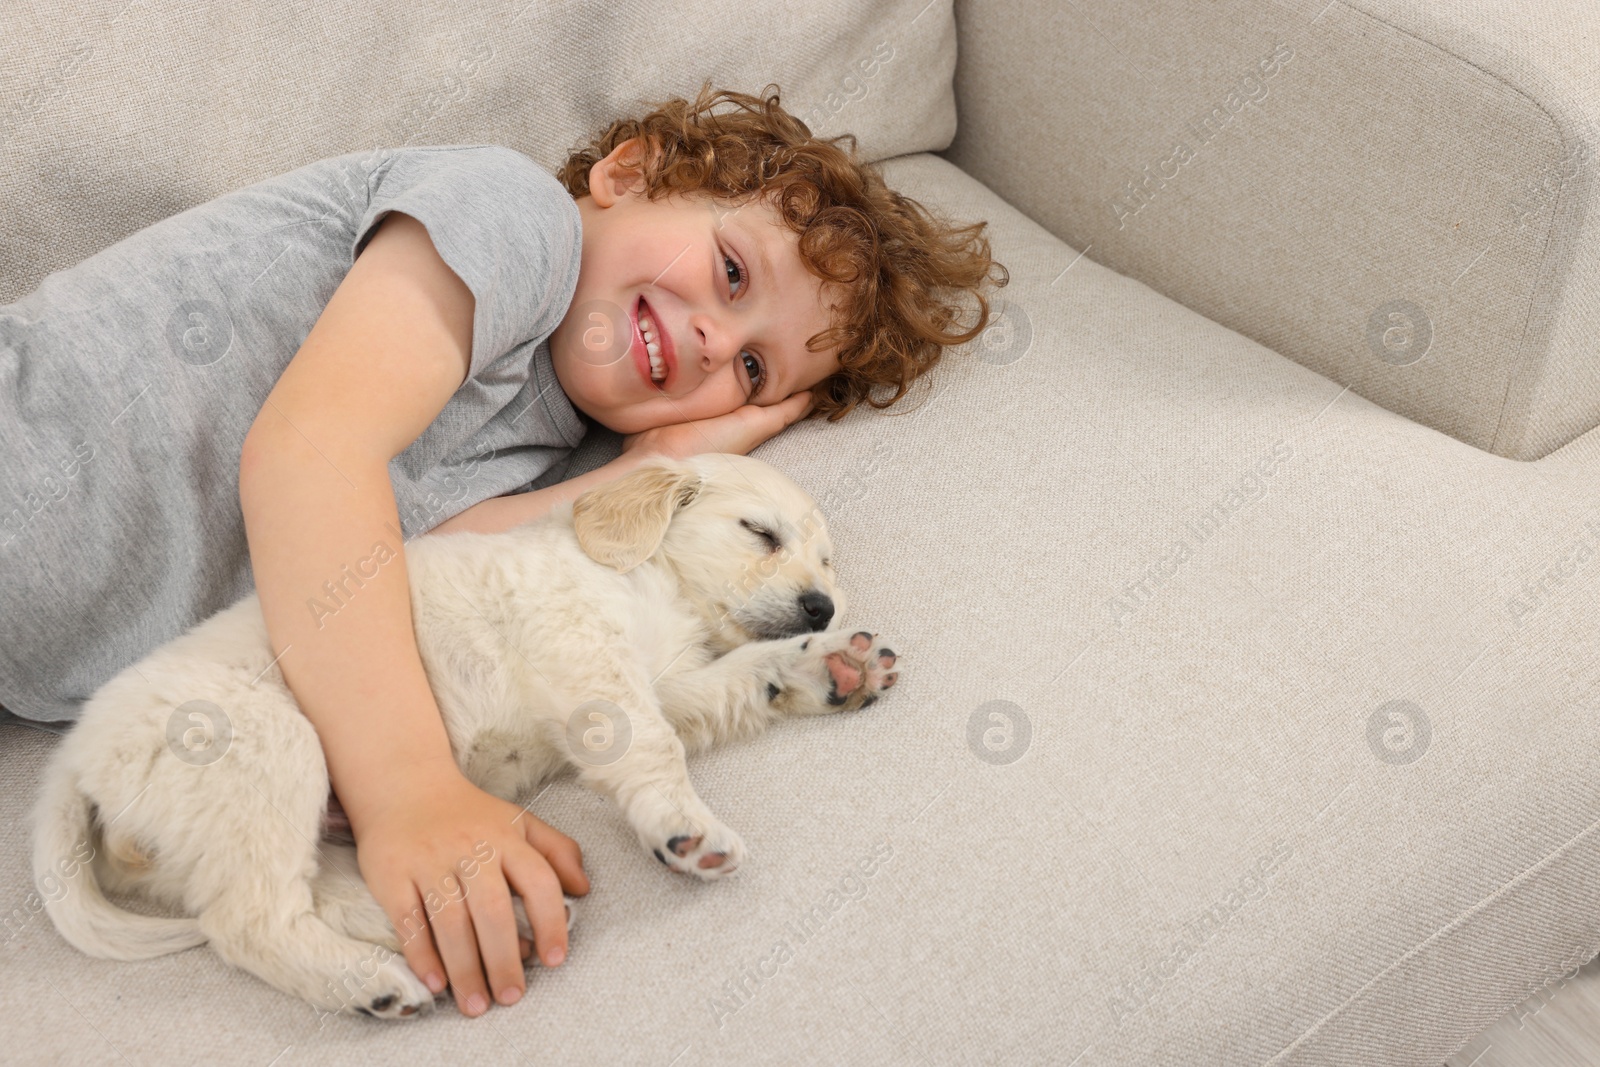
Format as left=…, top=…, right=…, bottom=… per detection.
left=656, top=630, right=899, bottom=752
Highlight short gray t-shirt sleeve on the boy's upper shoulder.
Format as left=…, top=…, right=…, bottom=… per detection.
left=350, top=144, right=582, bottom=378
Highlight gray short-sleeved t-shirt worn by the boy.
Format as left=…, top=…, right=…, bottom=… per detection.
left=0, top=144, right=587, bottom=720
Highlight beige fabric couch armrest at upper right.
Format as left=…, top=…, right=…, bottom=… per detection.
left=944, top=0, right=1600, bottom=459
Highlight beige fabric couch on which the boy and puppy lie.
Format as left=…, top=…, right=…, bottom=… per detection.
left=0, top=0, right=1600, bottom=1067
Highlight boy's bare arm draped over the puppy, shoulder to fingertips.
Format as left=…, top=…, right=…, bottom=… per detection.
left=240, top=213, right=587, bottom=1016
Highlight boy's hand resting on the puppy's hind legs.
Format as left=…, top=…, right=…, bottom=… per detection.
left=352, top=765, right=589, bottom=1016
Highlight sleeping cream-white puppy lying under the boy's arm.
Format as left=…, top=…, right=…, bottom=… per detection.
left=34, top=454, right=898, bottom=1017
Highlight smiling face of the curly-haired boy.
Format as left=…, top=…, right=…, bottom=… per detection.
left=550, top=141, right=838, bottom=434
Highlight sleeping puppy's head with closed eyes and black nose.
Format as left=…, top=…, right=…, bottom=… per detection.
left=573, top=453, right=845, bottom=648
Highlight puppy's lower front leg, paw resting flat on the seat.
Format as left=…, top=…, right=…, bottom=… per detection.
left=565, top=691, right=744, bottom=880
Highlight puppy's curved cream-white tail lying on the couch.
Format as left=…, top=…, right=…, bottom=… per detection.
left=34, top=774, right=208, bottom=960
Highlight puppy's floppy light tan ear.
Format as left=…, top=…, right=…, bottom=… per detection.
left=573, top=458, right=704, bottom=574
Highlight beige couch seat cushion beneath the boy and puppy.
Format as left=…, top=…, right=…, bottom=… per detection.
left=0, top=155, right=1600, bottom=1067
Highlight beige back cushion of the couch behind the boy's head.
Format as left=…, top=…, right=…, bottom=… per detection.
left=0, top=0, right=955, bottom=304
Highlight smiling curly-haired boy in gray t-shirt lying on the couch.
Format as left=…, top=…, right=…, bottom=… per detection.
left=0, top=85, right=1005, bottom=1016
